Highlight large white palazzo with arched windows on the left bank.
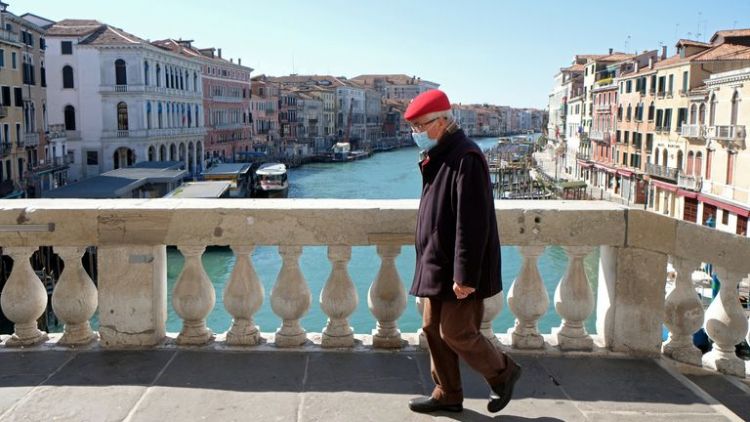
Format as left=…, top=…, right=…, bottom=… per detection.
left=46, top=19, right=206, bottom=180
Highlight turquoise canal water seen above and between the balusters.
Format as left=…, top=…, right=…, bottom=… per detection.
left=167, top=138, right=598, bottom=334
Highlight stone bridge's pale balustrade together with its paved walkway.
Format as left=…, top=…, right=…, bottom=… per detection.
left=0, top=199, right=750, bottom=420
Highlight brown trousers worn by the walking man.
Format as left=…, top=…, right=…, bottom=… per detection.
left=422, top=295, right=510, bottom=404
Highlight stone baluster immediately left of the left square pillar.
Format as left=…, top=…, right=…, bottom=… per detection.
left=52, top=246, right=98, bottom=346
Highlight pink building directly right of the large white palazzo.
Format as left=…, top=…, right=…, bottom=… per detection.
left=153, top=39, right=253, bottom=162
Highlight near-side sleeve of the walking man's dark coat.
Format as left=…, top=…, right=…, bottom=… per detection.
left=453, top=153, right=495, bottom=288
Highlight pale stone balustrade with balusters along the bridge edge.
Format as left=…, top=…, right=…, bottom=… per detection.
left=0, top=199, right=750, bottom=376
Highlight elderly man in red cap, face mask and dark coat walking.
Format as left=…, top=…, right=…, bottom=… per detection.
left=404, top=90, right=521, bottom=413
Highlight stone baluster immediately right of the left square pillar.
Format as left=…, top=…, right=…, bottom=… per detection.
left=172, top=245, right=216, bottom=345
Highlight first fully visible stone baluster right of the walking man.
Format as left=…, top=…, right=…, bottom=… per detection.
left=508, top=246, right=549, bottom=349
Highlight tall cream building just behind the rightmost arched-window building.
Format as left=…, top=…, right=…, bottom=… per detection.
left=648, top=30, right=750, bottom=223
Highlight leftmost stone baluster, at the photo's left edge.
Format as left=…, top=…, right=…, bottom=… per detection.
left=0, top=246, right=47, bottom=347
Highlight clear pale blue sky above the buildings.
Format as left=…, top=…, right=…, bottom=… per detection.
left=27, top=0, right=750, bottom=107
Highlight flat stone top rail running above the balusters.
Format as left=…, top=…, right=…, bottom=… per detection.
left=0, top=199, right=750, bottom=272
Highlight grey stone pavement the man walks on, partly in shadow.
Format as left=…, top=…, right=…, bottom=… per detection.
left=0, top=349, right=750, bottom=422
